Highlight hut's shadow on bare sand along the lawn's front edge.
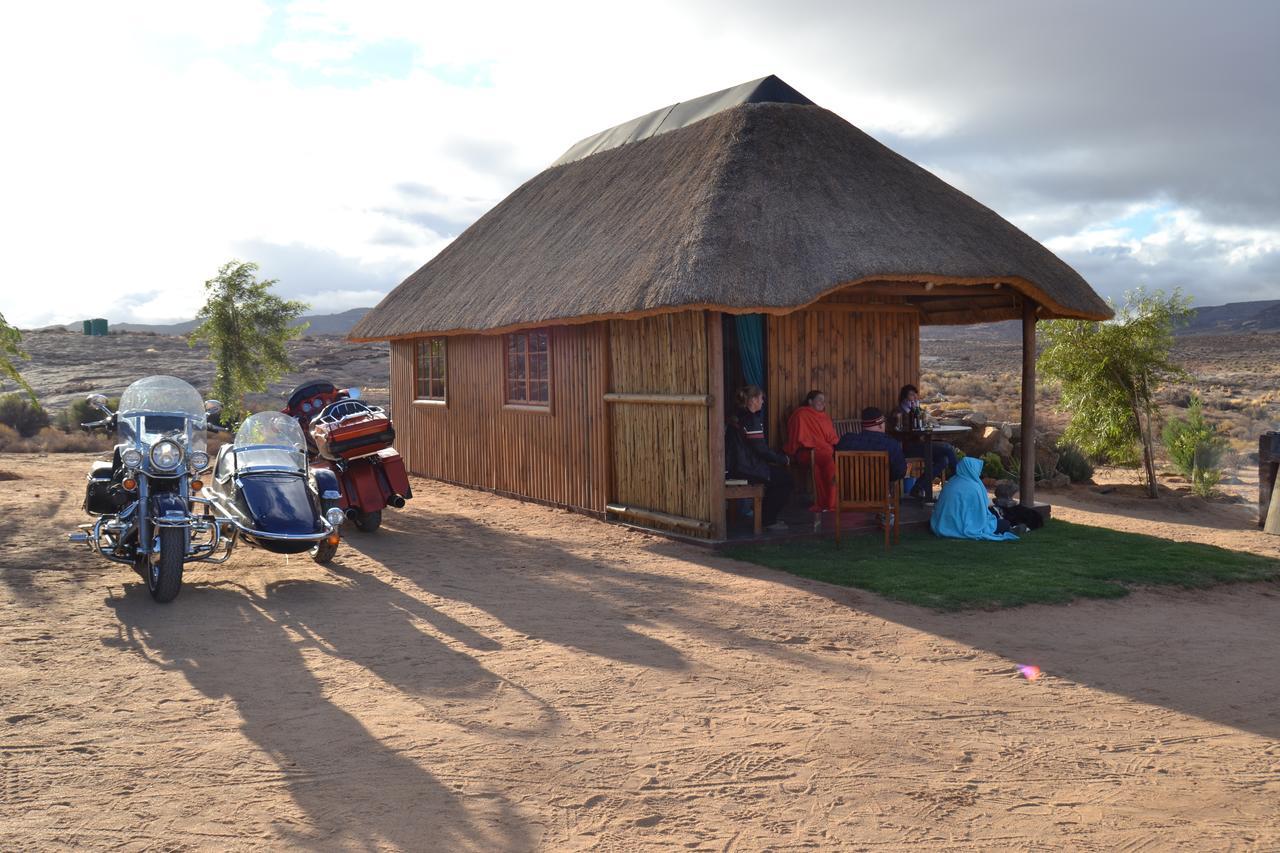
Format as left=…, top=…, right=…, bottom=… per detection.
left=652, top=532, right=1280, bottom=739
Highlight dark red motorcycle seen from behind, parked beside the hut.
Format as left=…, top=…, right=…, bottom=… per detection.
left=284, top=380, right=413, bottom=533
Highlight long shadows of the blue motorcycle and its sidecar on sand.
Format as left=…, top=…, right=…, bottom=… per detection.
left=106, top=573, right=535, bottom=849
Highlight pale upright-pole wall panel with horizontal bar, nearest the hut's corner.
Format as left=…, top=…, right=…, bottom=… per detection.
left=609, top=311, right=723, bottom=521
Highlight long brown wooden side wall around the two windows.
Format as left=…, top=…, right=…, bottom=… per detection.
left=390, top=323, right=609, bottom=514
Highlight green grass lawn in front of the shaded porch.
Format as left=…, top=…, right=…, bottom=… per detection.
left=723, top=521, right=1280, bottom=610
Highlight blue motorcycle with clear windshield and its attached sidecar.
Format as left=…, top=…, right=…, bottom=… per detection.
left=69, top=375, right=344, bottom=603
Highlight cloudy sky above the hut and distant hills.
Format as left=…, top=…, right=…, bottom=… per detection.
left=0, top=0, right=1280, bottom=328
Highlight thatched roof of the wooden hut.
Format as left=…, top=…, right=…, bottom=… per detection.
left=351, top=78, right=1111, bottom=339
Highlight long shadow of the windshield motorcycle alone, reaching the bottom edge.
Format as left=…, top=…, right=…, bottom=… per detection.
left=104, top=581, right=532, bottom=849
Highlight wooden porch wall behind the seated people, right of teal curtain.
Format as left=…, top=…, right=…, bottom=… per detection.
left=767, top=293, right=920, bottom=447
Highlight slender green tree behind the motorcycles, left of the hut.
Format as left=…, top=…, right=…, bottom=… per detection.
left=187, top=260, right=307, bottom=424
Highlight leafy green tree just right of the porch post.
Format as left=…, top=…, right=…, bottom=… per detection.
left=1037, top=288, right=1192, bottom=497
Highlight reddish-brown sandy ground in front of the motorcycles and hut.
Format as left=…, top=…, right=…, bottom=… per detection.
left=0, top=455, right=1280, bottom=850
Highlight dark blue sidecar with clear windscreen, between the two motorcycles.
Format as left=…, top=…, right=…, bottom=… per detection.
left=205, top=411, right=344, bottom=564
